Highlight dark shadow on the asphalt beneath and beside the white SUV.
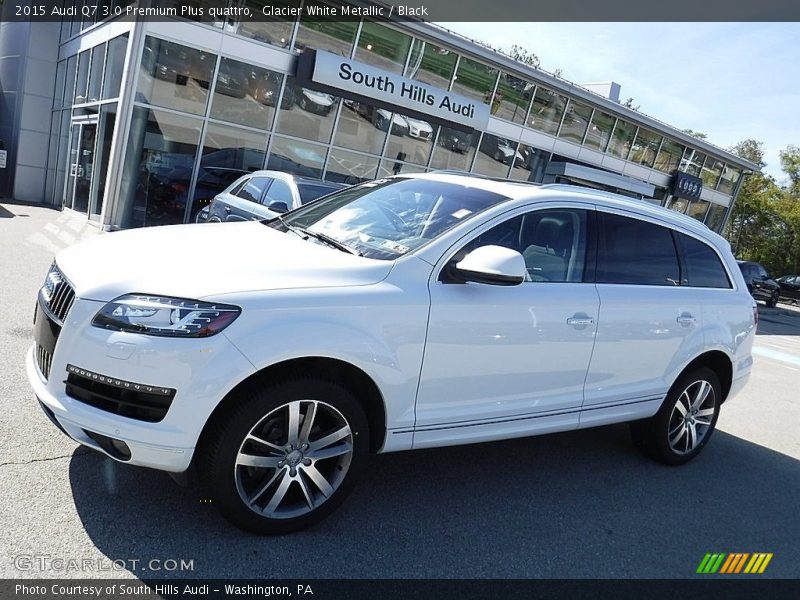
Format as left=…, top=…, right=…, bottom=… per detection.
left=69, top=425, right=800, bottom=579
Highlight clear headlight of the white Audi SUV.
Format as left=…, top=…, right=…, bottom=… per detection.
left=92, top=294, right=242, bottom=338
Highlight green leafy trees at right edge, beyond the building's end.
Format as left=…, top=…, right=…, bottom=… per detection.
left=725, top=139, right=800, bottom=277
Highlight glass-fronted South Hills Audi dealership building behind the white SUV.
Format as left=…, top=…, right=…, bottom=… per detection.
left=0, top=0, right=758, bottom=231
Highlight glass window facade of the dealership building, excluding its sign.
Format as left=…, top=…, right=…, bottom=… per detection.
left=42, top=12, right=741, bottom=236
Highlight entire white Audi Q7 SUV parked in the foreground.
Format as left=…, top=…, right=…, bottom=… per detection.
left=27, top=173, right=757, bottom=533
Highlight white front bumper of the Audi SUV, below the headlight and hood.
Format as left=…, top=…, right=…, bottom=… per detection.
left=25, top=299, right=254, bottom=472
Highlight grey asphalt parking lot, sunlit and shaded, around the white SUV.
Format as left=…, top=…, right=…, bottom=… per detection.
left=0, top=204, right=800, bottom=579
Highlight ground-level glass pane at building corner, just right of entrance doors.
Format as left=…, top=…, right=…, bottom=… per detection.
left=119, top=107, right=202, bottom=227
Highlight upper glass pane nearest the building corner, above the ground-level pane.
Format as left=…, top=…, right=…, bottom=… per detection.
left=136, top=36, right=217, bottom=114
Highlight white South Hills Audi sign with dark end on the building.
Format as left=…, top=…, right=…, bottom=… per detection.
left=297, top=49, right=489, bottom=130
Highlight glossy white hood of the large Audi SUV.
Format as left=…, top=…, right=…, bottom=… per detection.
left=56, top=221, right=393, bottom=301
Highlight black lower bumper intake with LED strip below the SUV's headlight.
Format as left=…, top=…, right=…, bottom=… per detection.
left=64, top=365, right=175, bottom=423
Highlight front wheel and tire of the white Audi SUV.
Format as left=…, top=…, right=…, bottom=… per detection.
left=197, top=377, right=369, bottom=535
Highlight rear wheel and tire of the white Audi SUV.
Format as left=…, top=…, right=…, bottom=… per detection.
left=631, top=367, right=722, bottom=465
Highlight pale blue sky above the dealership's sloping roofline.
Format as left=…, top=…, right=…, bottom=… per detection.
left=439, top=23, right=800, bottom=182
